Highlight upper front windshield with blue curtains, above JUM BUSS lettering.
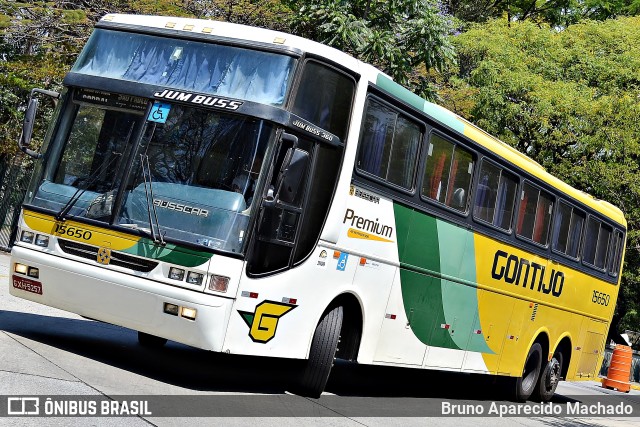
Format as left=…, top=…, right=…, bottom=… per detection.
left=72, top=29, right=296, bottom=106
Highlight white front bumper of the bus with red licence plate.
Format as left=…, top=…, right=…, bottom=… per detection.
left=9, top=246, right=234, bottom=352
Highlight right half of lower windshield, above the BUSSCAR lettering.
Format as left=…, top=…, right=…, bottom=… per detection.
left=116, top=105, right=273, bottom=252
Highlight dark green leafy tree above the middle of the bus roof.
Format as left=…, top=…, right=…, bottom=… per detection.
left=289, top=0, right=454, bottom=98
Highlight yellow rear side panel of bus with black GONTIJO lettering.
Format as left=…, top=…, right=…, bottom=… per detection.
left=475, top=234, right=617, bottom=377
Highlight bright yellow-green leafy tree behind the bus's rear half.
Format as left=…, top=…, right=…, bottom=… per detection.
left=440, top=17, right=640, bottom=336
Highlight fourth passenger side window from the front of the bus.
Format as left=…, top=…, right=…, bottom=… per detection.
left=516, top=183, right=553, bottom=245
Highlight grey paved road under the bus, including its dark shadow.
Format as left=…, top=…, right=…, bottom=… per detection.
left=0, top=252, right=640, bottom=427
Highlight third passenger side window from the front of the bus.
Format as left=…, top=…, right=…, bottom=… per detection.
left=473, top=161, right=518, bottom=230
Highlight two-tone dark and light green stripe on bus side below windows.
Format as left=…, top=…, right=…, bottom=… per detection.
left=394, top=204, right=492, bottom=353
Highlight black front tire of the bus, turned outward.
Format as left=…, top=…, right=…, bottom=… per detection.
left=298, top=306, right=343, bottom=399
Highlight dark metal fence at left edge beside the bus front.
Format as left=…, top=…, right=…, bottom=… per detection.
left=0, top=154, right=33, bottom=251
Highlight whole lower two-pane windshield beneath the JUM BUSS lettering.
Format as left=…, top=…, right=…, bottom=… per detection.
left=26, top=98, right=274, bottom=253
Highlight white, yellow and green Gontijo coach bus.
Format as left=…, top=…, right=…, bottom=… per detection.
left=10, top=15, right=626, bottom=401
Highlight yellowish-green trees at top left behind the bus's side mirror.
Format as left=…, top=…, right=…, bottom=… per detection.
left=0, top=0, right=200, bottom=153
